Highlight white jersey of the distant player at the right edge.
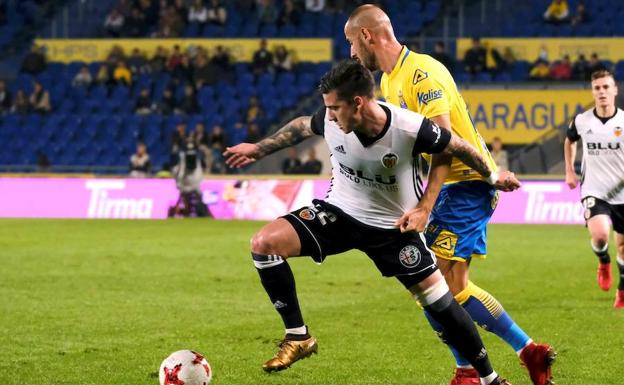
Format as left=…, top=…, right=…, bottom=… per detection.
left=567, top=108, right=624, bottom=204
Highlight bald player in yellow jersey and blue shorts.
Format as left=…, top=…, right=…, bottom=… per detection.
left=344, top=5, right=555, bottom=385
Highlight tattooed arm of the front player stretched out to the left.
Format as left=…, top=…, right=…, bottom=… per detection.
left=223, top=116, right=314, bottom=168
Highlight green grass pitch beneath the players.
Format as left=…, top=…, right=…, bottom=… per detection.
left=0, top=220, right=624, bottom=385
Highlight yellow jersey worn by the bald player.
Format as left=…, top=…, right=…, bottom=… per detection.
left=381, top=46, right=496, bottom=183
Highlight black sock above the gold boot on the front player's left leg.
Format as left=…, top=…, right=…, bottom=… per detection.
left=252, top=254, right=304, bottom=329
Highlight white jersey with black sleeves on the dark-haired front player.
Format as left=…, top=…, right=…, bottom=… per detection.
left=312, top=102, right=451, bottom=229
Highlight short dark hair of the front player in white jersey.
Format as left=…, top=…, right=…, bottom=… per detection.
left=318, top=59, right=375, bottom=103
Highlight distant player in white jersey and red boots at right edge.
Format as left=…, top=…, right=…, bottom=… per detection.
left=564, top=70, right=624, bottom=309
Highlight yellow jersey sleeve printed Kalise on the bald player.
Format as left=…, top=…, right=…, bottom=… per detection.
left=404, top=69, right=451, bottom=118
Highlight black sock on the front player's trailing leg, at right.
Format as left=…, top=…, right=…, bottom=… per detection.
left=425, top=292, right=494, bottom=377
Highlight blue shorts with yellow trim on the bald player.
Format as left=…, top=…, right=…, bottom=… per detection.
left=425, top=181, right=498, bottom=261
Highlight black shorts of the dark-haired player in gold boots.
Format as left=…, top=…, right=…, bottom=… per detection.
left=282, top=200, right=437, bottom=284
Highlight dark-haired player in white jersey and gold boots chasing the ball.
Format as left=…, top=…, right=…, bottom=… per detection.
left=224, top=60, right=519, bottom=385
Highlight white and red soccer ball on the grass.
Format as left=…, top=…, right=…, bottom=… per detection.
left=158, top=350, right=212, bottom=385
